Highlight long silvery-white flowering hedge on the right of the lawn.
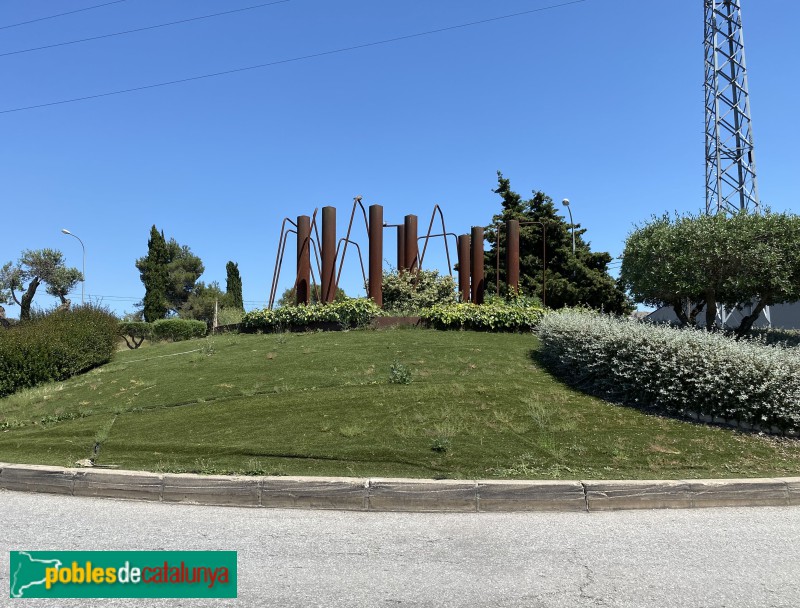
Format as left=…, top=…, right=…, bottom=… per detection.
left=536, top=309, right=800, bottom=432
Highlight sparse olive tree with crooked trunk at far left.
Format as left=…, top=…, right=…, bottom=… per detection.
left=0, top=249, right=83, bottom=321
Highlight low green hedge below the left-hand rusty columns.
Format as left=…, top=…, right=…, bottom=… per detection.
left=241, top=298, right=381, bottom=333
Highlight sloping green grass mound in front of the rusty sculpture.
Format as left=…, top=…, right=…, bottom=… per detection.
left=0, top=329, right=800, bottom=479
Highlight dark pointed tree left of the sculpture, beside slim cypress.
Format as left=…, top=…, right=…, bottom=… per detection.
left=136, top=226, right=204, bottom=321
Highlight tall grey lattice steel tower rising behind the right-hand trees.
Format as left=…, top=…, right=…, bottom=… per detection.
left=704, top=0, right=759, bottom=214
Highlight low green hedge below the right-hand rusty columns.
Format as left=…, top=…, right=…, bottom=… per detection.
left=420, top=301, right=544, bottom=332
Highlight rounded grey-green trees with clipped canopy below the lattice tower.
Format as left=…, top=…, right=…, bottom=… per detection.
left=620, top=211, right=800, bottom=336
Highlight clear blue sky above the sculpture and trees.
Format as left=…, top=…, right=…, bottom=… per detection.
left=0, top=0, right=800, bottom=316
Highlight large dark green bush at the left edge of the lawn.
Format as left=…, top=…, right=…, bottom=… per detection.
left=0, top=305, right=119, bottom=397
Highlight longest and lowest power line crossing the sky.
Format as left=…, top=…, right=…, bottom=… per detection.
left=0, top=0, right=588, bottom=114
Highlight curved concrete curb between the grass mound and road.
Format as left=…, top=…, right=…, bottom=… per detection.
left=0, top=463, right=800, bottom=513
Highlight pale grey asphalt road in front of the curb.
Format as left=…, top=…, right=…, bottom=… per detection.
left=0, top=490, right=800, bottom=608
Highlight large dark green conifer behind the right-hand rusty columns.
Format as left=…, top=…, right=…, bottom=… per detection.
left=485, top=171, right=631, bottom=314
